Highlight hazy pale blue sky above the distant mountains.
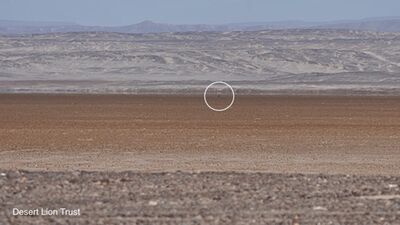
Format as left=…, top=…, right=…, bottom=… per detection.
left=0, top=0, right=400, bottom=25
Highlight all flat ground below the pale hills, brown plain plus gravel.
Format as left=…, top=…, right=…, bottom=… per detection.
left=0, top=94, right=400, bottom=225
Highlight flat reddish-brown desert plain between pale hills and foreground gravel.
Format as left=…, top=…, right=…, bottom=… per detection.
left=0, top=94, right=400, bottom=175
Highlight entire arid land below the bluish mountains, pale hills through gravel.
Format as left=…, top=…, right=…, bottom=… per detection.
left=0, top=26, right=400, bottom=225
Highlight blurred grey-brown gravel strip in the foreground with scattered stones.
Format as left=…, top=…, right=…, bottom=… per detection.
left=0, top=171, right=400, bottom=225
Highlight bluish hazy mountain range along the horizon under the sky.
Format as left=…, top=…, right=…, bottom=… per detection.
left=0, top=17, right=400, bottom=35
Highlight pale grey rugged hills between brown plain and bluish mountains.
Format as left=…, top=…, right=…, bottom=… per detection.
left=0, top=29, right=400, bottom=93
